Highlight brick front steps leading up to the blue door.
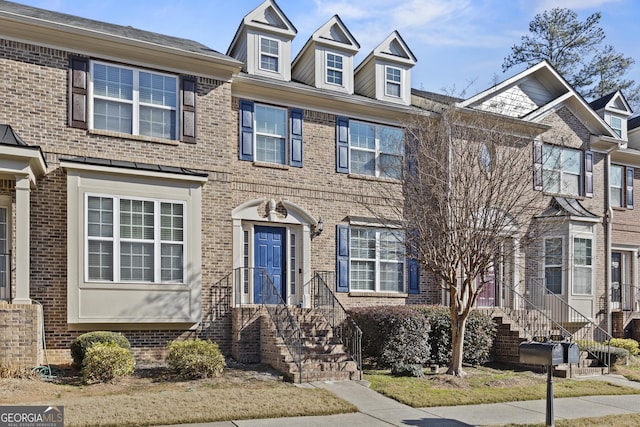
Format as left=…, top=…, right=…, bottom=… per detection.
left=260, top=308, right=360, bottom=382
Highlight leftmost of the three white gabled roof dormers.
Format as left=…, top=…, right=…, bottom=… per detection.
left=227, top=0, right=298, bottom=81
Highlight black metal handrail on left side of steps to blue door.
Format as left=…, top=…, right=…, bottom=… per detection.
left=256, top=269, right=302, bottom=383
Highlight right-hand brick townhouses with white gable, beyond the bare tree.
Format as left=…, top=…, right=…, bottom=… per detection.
left=457, top=62, right=640, bottom=362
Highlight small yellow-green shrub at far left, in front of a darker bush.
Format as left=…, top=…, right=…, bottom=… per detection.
left=82, top=342, right=135, bottom=384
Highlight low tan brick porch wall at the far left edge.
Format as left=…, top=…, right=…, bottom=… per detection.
left=0, top=302, right=44, bottom=368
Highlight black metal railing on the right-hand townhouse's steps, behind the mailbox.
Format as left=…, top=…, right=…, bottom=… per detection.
left=502, top=279, right=611, bottom=371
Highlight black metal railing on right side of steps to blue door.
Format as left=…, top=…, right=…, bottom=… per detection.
left=311, top=271, right=362, bottom=379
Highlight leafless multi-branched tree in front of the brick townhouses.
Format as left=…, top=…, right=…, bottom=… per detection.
left=372, top=107, right=543, bottom=376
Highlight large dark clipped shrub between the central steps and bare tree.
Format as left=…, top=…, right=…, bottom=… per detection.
left=351, top=306, right=430, bottom=367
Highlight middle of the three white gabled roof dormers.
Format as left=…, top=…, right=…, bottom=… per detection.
left=292, top=15, right=360, bottom=94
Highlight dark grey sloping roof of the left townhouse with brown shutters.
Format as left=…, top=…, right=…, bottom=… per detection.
left=0, top=0, right=236, bottom=61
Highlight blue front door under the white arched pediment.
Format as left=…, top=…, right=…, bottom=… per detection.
left=253, top=226, right=286, bottom=304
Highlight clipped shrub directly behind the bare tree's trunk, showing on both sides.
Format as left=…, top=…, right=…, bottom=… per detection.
left=418, top=306, right=496, bottom=365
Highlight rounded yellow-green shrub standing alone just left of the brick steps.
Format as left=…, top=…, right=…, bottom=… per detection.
left=167, top=339, right=226, bottom=379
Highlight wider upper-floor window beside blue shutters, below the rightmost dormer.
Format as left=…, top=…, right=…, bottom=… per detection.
left=349, top=120, right=404, bottom=179
